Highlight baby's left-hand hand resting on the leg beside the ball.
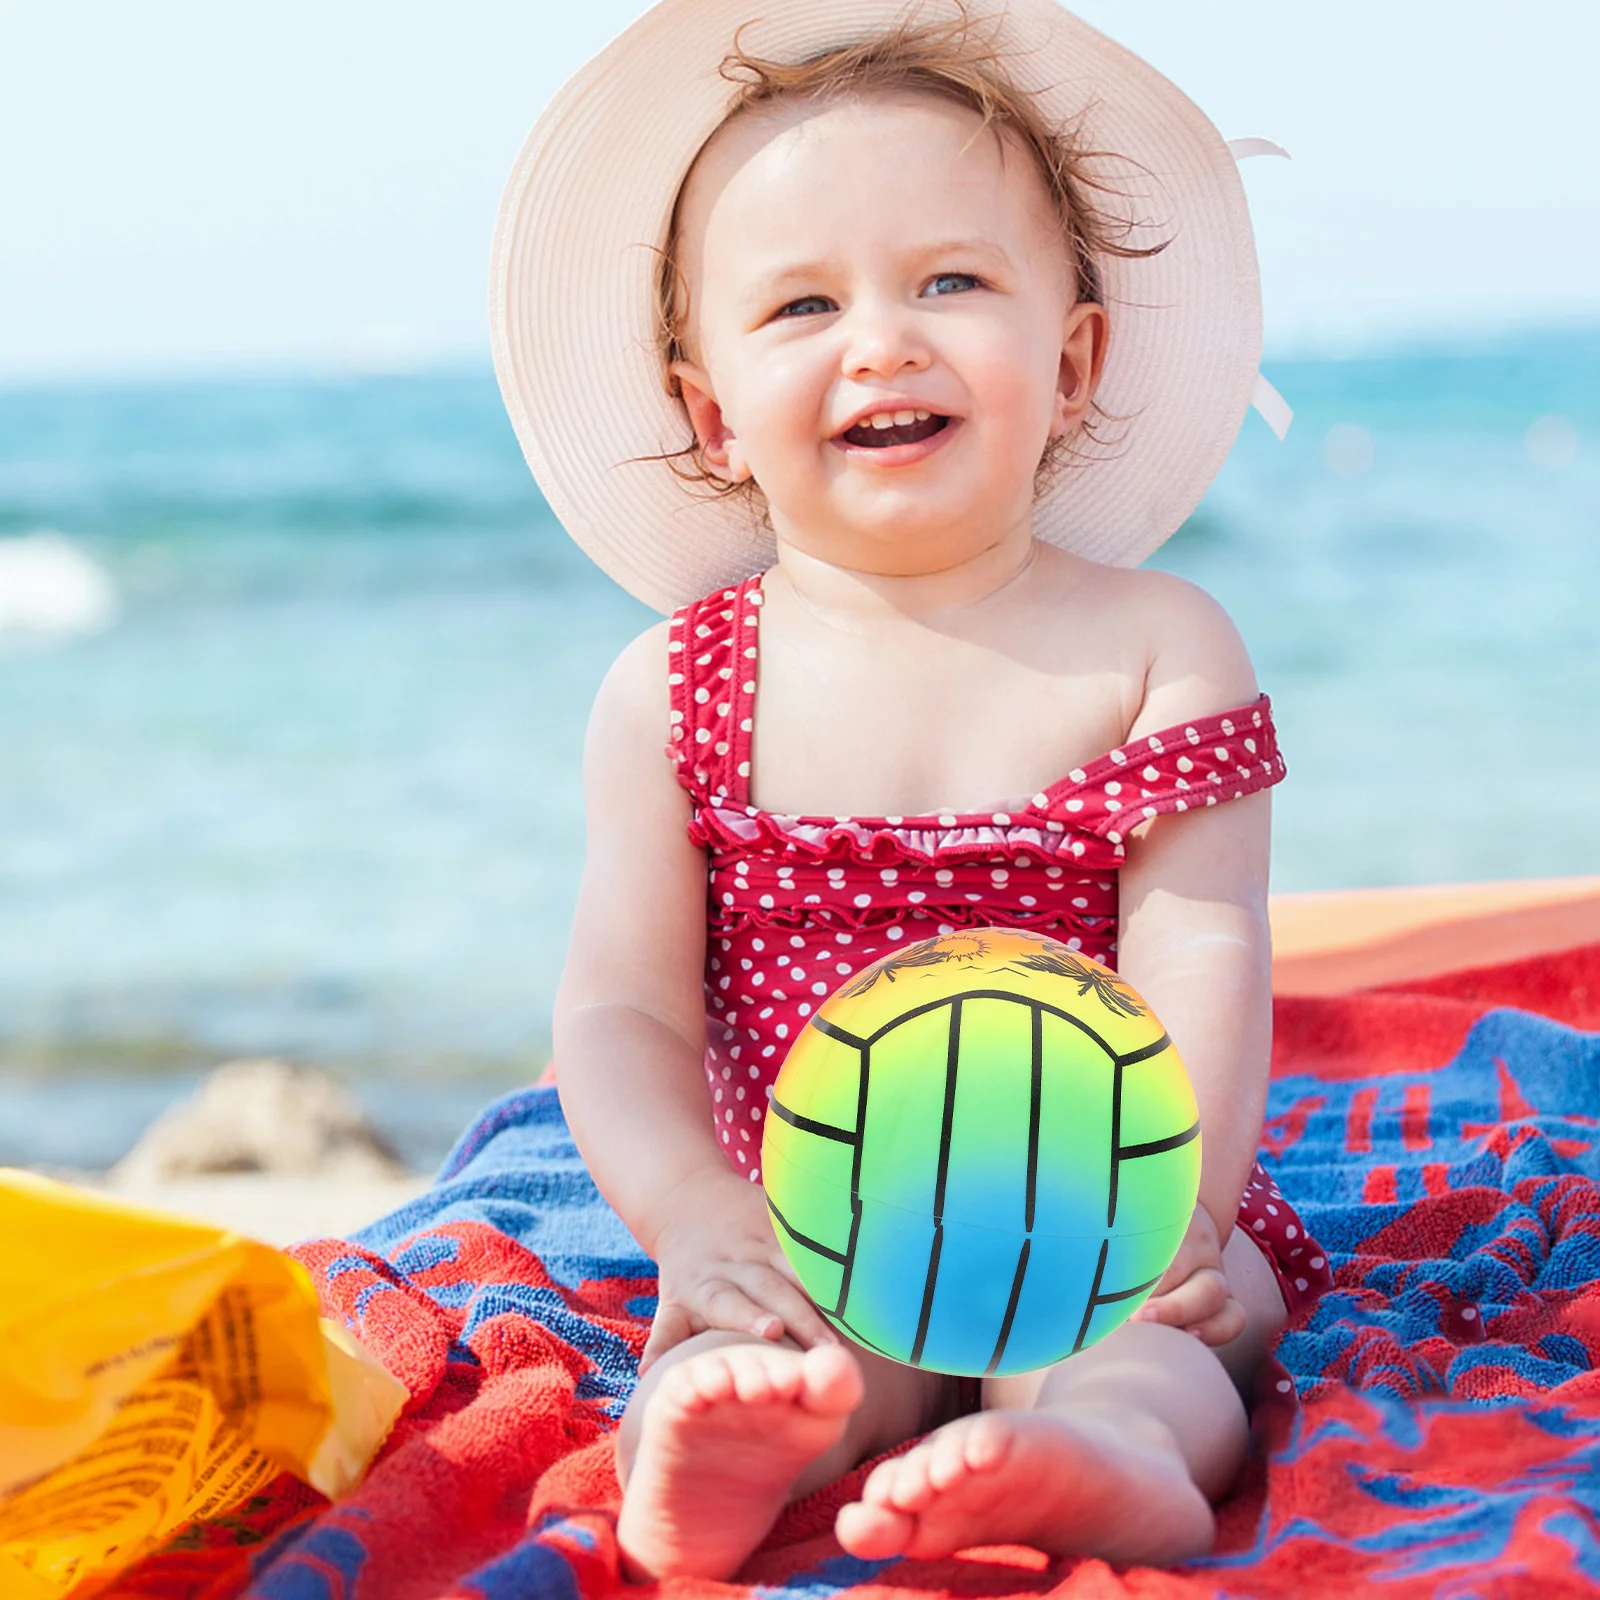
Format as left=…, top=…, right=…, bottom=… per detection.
left=638, top=1171, right=837, bottom=1373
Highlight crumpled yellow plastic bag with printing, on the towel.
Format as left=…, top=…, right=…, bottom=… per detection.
left=0, top=1170, right=406, bottom=1600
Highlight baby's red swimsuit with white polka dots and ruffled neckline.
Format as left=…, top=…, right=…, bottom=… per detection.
left=667, top=578, right=1331, bottom=1312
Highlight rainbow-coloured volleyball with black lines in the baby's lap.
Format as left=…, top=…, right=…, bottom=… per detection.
left=762, top=928, right=1200, bottom=1376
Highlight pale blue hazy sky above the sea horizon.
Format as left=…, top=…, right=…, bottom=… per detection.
left=0, top=0, right=1600, bottom=381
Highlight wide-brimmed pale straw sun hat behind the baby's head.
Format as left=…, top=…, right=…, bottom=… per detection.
left=490, top=0, right=1286, bottom=611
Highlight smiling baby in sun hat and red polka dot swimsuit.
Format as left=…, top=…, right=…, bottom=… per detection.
left=498, top=0, right=1326, bottom=1578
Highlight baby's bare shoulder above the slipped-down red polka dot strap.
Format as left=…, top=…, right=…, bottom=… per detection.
left=1106, top=568, right=1259, bottom=738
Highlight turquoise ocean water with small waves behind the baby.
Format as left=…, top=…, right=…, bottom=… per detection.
left=0, top=330, right=1600, bottom=1165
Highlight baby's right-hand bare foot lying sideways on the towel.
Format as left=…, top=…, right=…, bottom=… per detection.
left=835, top=1410, right=1214, bottom=1565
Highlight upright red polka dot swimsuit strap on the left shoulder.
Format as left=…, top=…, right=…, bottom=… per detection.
left=667, top=574, right=763, bottom=806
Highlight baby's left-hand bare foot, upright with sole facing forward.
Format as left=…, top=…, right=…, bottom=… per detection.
left=616, top=1344, right=862, bottom=1578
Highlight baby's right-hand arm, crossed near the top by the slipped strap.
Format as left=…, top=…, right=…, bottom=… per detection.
left=1117, top=573, right=1272, bottom=1344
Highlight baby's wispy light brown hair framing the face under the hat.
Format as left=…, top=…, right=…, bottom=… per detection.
left=653, top=9, right=1166, bottom=498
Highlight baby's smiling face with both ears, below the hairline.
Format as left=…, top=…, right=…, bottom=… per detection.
left=675, top=96, right=1106, bottom=574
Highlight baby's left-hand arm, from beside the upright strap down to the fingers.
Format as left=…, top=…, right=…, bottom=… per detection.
left=554, top=624, right=829, bottom=1365
